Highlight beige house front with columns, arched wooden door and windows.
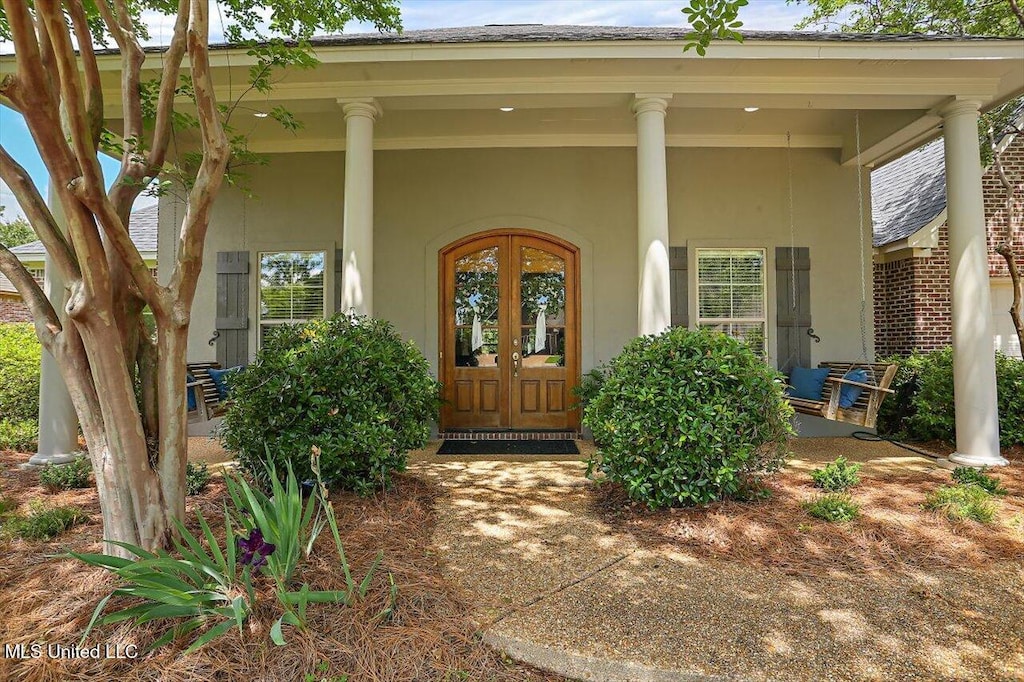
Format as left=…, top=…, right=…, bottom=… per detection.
left=18, top=26, right=1024, bottom=462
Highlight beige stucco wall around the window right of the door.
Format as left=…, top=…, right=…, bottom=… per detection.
left=669, top=148, right=873, bottom=365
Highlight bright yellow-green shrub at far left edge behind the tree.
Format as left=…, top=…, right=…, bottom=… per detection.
left=0, top=323, right=42, bottom=422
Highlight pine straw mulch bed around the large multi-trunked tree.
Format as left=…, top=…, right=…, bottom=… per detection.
left=0, top=453, right=561, bottom=682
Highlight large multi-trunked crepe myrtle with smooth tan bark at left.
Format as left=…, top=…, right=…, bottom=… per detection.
left=0, top=0, right=400, bottom=555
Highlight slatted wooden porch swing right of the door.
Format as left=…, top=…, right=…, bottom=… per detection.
left=787, top=363, right=898, bottom=429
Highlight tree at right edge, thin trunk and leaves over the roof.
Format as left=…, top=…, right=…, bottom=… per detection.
left=682, top=0, right=1024, bottom=348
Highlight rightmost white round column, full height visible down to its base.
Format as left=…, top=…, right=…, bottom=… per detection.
left=942, top=100, right=1007, bottom=466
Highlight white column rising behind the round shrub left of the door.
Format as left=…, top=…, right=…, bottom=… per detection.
left=338, top=99, right=381, bottom=315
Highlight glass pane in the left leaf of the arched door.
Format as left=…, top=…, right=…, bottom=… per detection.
left=455, top=247, right=499, bottom=367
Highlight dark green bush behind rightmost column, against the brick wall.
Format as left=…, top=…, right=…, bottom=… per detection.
left=879, top=348, right=1024, bottom=447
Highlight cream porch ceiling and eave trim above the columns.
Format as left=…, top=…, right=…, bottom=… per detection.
left=6, top=31, right=1024, bottom=166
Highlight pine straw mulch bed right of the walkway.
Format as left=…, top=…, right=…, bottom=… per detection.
left=594, top=447, right=1024, bottom=578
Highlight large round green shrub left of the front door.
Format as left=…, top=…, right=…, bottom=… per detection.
left=221, top=315, right=439, bottom=494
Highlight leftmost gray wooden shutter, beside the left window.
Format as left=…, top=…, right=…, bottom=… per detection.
left=217, top=251, right=249, bottom=368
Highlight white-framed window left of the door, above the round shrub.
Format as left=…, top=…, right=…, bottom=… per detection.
left=259, top=251, right=326, bottom=345
